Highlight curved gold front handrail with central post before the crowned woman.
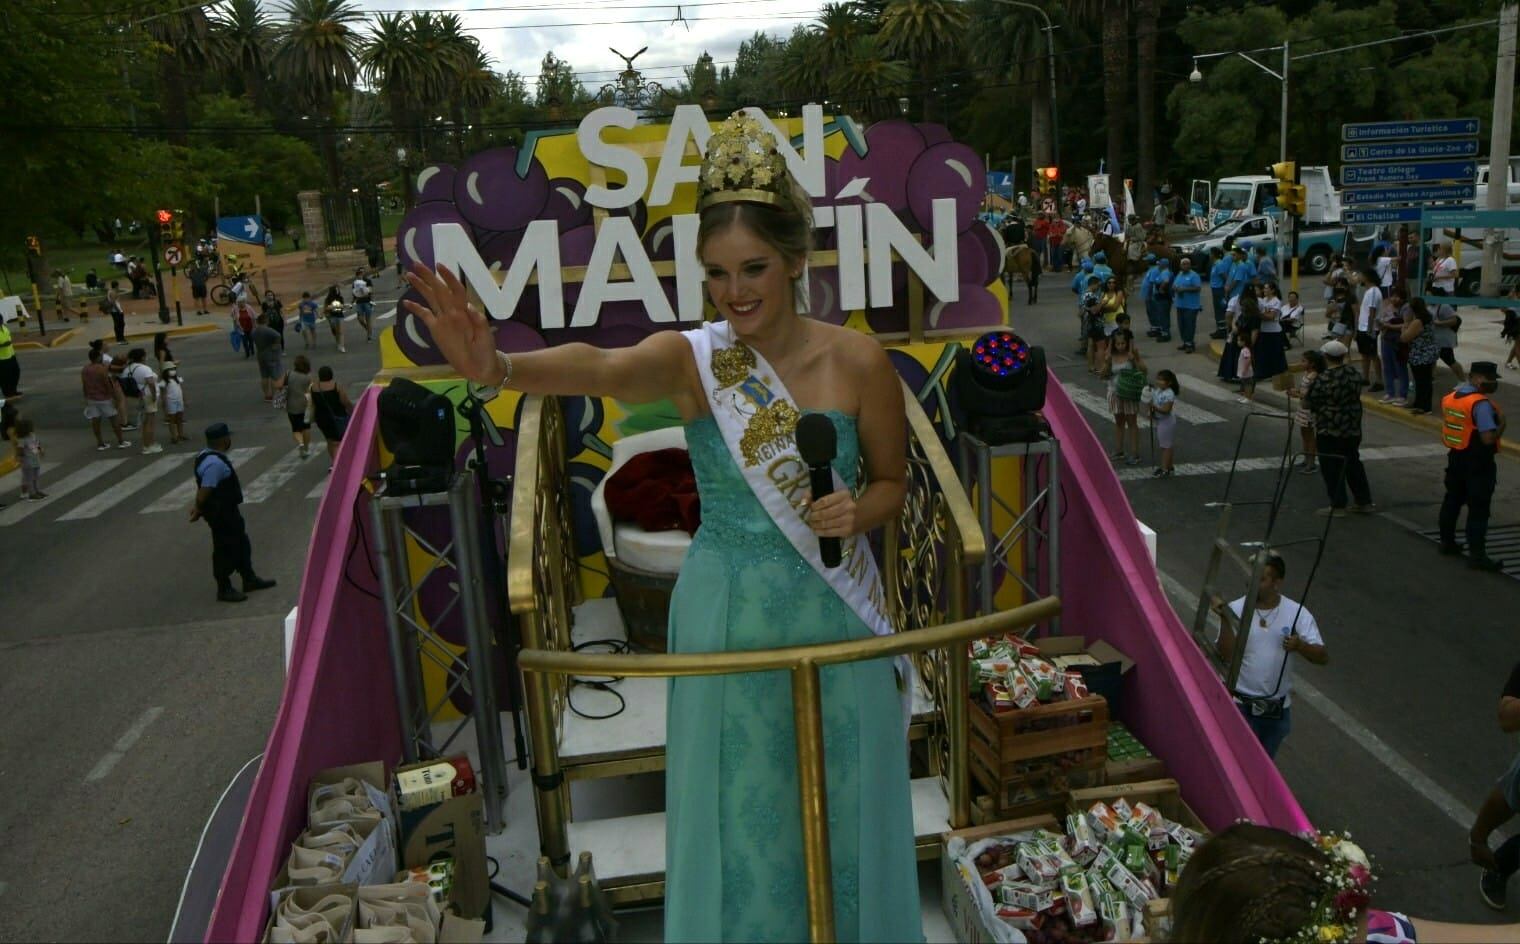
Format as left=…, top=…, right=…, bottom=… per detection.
left=518, top=597, right=1061, bottom=941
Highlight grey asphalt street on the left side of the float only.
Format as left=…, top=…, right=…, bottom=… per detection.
left=0, top=272, right=398, bottom=941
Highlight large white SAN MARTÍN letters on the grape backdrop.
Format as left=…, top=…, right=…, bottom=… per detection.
left=432, top=105, right=959, bottom=328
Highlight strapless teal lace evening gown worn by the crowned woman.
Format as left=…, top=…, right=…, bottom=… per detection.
left=666, top=412, right=923, bottom=941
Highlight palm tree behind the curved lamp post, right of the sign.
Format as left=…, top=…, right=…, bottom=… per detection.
left=967, top=0, right=1055, bottom=167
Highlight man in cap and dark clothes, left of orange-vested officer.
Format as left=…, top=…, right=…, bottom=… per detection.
left=1304, top=341, right=1377, bottom=518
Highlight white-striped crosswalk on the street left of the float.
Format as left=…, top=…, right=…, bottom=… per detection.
left=0, top=442, right=328, bottom=527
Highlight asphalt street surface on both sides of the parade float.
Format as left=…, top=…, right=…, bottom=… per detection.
left=0, top=262, right=1520, bottom=941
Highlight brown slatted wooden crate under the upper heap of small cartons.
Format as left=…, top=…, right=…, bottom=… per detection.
left=967, top=695, right=1108, bottom=818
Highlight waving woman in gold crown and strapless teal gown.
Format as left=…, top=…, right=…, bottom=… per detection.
left=404, top=108, right=923, bottom=941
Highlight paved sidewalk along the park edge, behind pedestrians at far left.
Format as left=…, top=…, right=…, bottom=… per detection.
left=11, top=237, right=395, bottom=351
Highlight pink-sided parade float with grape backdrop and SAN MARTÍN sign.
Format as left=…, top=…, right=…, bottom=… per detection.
left=192, top=106, right=1307, bottom=941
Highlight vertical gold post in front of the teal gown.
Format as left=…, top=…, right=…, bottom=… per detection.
left=792, top=658, right=836, bottom=942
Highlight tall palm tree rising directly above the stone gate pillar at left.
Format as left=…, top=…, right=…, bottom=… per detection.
left=271, top=0, right=363, bottom=190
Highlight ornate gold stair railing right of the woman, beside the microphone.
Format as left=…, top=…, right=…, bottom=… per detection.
left=882, top=378, right=986, bottom=827
